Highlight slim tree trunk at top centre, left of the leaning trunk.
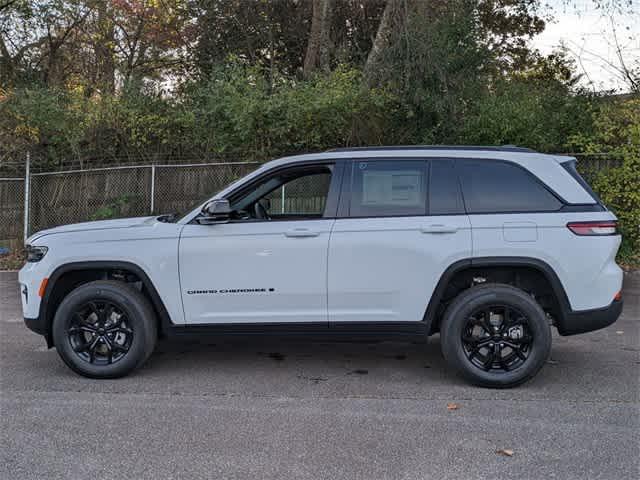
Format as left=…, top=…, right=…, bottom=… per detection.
left=302, top=0, right=333, bottom=78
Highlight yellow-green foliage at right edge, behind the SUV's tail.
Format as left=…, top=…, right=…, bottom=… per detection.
left=570, top=98, right=640, bottom=265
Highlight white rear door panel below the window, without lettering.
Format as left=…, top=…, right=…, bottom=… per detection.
left=328, top=215, right=471, bottom=322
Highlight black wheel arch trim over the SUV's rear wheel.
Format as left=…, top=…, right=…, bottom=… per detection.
left=423, top=256, right=571, bottom=335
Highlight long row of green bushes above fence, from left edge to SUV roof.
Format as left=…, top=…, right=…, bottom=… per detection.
left=0, top=65, right=401, bottom=164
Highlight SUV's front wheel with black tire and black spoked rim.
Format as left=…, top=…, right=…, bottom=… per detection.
left=52, top=280, right=157, bottom=378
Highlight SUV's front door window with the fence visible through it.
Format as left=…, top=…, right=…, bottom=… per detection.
left=230, top=165, right=332, bottom=220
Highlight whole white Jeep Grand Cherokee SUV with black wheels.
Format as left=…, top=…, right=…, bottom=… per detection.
left=20, top=147, right=622, bottom=387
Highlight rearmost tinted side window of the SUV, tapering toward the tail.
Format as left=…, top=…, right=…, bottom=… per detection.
left=457, top=159, right=562, bottom=213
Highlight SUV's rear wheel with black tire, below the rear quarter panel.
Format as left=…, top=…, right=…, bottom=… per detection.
left=440, top=283, right=551, bottom=388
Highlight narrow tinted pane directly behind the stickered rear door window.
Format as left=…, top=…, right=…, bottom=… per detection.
left=429, top=159, right=464, bottom=215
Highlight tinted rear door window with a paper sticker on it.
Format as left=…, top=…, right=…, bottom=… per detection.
left=349, top=160, right=426, bottom=217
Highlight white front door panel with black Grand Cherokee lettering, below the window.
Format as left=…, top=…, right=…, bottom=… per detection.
left=180, top=219, right=334, bottom=324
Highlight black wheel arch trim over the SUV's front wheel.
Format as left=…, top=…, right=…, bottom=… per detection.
left=39, top=260, right=172, bottom=348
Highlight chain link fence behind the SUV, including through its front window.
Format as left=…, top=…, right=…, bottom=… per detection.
left=0, top=154, right=621, bottom=249
